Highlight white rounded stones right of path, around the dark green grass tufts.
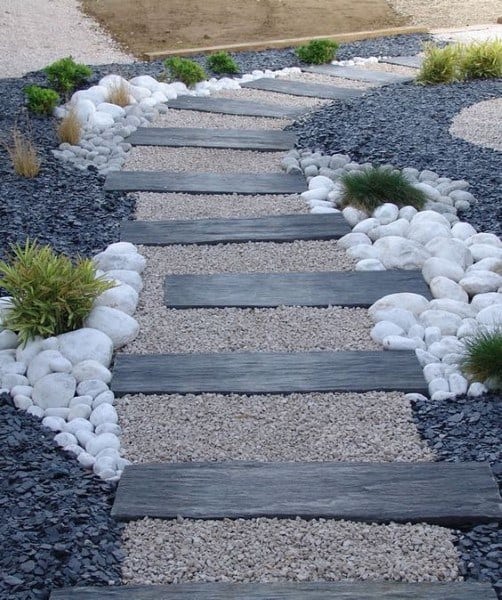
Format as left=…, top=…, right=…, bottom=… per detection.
left=283, top=151, right=502, bottom=400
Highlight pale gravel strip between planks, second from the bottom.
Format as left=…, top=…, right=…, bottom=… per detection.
left=117, top=392, right=434, bottom=463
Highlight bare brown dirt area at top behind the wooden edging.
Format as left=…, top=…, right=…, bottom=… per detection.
left=78, top=0, right=410, bottom=56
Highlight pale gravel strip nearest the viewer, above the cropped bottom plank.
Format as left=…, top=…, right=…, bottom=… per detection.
left=122, top=518, right=459, bottom=584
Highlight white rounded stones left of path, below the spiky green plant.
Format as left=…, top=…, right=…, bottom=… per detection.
left=0, top=242, right=146, bottom=480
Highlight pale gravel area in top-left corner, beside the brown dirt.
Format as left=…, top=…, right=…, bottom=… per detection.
left=0, top=0, right=135, bottom=77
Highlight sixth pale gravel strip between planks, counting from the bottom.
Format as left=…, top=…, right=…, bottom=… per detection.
left=123, top=146, right=284, bottom=173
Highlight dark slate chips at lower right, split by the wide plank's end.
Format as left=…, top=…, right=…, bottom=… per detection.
left=413, top=393, right=502, bottom=598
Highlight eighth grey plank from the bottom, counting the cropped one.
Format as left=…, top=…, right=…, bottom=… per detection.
left=167, top=96, right=305, bottom=119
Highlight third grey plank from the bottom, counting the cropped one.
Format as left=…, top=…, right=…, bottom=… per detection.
left=111, top=351, right=427, bottom=395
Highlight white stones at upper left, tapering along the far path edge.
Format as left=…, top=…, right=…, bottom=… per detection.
left=53, top=67, right=300, bottom=175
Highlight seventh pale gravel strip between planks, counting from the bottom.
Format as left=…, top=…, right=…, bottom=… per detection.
left=155, top=108, right=292, bottom=129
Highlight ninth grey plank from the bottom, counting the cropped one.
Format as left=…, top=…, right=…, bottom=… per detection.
left=241, top=77, right=364, bottom=100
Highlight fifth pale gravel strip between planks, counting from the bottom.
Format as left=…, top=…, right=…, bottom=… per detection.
left=135, top=192, right=309, bottom=221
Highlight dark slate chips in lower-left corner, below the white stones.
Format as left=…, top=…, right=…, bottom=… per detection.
left=0, top=394, right=123, bottom=600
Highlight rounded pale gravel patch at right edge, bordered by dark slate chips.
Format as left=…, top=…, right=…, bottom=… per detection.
left=450, top=98, right=502, bottom=151
